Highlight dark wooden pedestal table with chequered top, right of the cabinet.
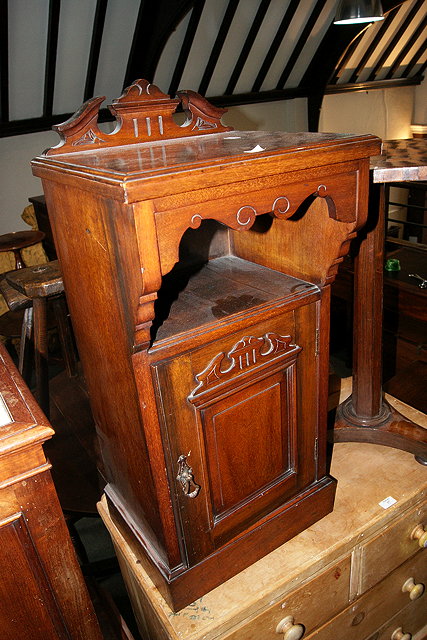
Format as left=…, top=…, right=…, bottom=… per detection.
left=334, top=140, right=427, bottom=464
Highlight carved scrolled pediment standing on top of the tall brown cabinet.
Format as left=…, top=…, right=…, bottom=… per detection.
left=45, top=80, right=232, bottom=155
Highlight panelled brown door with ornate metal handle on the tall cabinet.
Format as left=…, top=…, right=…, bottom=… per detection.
left=152, top=302, right=319, bottom=563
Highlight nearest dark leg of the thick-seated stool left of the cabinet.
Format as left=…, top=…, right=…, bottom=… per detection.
left=33, top=298, right=49, bottom=417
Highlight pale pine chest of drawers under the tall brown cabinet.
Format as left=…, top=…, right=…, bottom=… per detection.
left=99, top=420, right=427, bottom=640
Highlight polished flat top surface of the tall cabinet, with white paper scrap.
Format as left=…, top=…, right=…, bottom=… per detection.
left=33, top=131, right=379, bottom=180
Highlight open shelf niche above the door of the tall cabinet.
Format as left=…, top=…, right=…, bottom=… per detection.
left=152, top=214, right=319, bottom=349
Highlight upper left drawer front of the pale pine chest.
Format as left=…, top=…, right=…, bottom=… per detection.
left=224, top=557, right=350, bottom=640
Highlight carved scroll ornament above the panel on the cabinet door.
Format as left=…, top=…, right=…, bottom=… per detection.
left=189, top=333, right=301, bottom=401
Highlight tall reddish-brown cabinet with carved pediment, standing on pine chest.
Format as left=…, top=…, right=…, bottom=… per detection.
left=33, top=81, right=379, bottom=609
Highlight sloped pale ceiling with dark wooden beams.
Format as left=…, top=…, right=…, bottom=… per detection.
left=0, top=0, right=427, bottom=136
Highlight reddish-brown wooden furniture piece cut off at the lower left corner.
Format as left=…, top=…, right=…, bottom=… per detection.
left=0, top=347, right=102, bottom=640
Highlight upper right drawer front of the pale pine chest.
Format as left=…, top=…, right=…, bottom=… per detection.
left=358, top=502, right=427, bottom=594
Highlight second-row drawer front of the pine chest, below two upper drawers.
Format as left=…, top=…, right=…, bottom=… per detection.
left=306, top=553, right=427, bottom=640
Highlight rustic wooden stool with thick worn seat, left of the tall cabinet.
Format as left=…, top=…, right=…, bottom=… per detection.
left=1, top=260, right=76, bottom=415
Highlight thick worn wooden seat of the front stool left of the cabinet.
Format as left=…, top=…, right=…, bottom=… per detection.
left=6, top=260, right=64, bottom=298
